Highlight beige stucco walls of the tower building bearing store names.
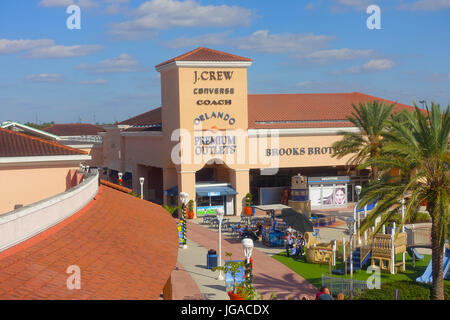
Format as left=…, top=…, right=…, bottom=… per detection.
left=103, top=61, right=358, bottom=215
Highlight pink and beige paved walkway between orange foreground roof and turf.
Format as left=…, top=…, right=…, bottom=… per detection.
left=174, top=221, right=317, bottom=300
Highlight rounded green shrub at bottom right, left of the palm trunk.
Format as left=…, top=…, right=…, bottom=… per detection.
left=354, top=280, right=430, bottom=300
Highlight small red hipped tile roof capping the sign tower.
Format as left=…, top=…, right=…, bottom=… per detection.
left=155, top=47, right=253, bottom=68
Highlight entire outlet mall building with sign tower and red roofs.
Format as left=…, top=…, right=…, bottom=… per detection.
left=100, top=48, right=412, bottom=216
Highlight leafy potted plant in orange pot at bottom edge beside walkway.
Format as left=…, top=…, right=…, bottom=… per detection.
left=211, top=252, right=262, bottom=300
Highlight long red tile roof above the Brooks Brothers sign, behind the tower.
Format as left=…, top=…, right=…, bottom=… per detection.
left=120, top=92, right=414, bottom=131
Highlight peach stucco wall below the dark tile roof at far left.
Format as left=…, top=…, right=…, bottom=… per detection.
left=0, top=164, right=79, bottom=214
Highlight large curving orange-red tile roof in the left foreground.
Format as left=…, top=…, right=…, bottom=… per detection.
left=0, top=186, right=178, bottom=300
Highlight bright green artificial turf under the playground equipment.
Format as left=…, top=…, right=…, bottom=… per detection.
left=273, top=251, right=450, bottom=289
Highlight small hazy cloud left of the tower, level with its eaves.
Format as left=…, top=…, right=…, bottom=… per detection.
left=76, top=53, right=145, bottom=74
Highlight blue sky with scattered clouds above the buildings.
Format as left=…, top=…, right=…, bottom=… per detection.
left=0, top=0, right=450, bottom=123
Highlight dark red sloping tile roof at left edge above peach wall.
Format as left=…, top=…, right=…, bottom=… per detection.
left=0, top=128, right=88, bottom=157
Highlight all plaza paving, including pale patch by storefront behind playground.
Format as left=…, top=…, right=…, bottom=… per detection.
left=172, top=208, right=353, bottom=300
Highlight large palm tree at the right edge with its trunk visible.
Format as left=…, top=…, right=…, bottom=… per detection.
left=359, top=103, right=450, bottom=300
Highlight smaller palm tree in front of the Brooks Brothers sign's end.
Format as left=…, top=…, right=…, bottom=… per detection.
left=332, top=101, right=394, bottom=179
